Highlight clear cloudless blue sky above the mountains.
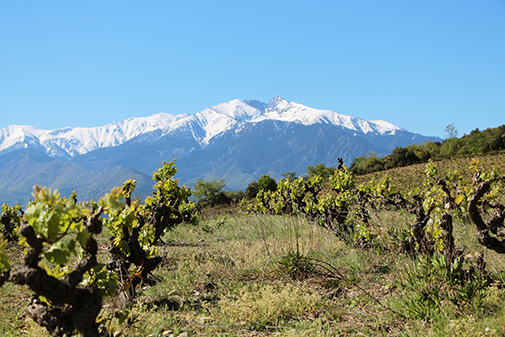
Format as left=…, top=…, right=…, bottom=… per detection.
left=0, top=0, right=505, bottom=137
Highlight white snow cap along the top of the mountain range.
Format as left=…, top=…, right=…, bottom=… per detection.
left=0, top=96, right=402, bottom=157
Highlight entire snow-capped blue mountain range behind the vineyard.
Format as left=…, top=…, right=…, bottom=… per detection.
left=0, top=96, right=441, bottom=204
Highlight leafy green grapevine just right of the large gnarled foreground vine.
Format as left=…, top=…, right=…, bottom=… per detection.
left=100, top=161, right=198, bottom=316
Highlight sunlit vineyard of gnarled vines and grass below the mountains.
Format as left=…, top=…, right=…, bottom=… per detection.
left=0, top=155, right=505, bottom=336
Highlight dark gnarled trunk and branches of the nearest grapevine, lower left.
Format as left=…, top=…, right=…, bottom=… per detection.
left=8, top=209, right=102, bottom=336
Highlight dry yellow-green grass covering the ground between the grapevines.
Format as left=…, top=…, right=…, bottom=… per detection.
left=0, top=157, right=505, bottom=336
